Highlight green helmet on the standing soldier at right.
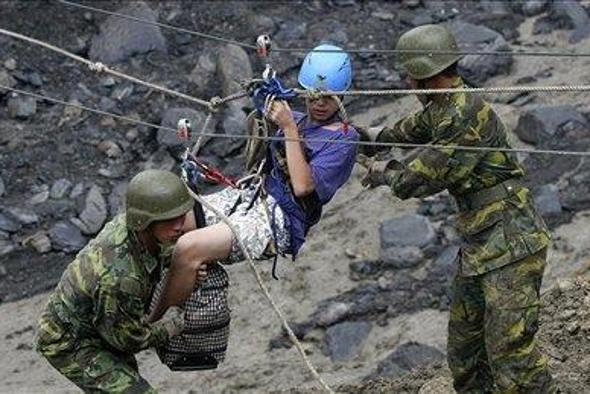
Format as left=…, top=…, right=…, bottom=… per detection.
left=395, top=25, right=461, bottom=80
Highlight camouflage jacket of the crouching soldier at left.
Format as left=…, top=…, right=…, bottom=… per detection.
left=39, top=215, right=168, bottom=353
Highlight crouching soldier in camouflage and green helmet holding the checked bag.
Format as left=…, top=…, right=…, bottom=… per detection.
left=36, top=170, right=204, bottom=393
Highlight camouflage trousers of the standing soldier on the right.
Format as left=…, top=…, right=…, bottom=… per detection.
left=447, top=249, right=556, bottom=393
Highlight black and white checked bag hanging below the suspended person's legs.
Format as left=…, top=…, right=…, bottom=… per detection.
left=151, top=263, right=230, bottom=370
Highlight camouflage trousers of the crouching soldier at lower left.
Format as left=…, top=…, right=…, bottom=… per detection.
left=36, top=313, right=157, bottom=393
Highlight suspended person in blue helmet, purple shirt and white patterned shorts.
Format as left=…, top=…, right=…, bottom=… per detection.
left=150, top=45, right=359, bottom=330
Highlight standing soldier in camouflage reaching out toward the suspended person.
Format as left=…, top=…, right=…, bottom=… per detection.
left=359, top=25, right=555, bottom=393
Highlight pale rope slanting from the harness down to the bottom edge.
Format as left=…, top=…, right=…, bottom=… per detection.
left=183, top=185, right=334, bottom=393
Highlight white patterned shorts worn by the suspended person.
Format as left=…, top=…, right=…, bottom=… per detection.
left=203, top=188, right=291, bottom=263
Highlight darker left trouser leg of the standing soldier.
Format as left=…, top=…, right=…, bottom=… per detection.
left=447, top=276, right=493, bottom=393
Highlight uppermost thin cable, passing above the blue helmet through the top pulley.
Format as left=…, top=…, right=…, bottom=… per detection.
left=57, top=0, right=590, bottom=57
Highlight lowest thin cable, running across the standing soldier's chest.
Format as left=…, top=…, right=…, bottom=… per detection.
left=0, top=84, right=590, bottom=157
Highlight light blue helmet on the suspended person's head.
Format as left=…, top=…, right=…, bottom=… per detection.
left=299, top=44, right=352, bottom=91
